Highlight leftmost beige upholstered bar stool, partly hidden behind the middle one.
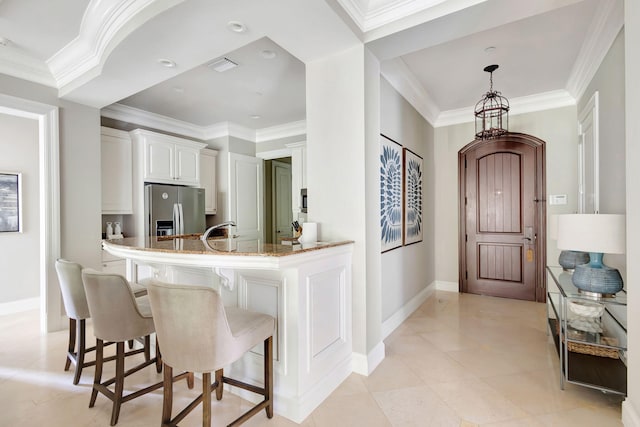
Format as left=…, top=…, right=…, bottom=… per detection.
left=56, top=259, right=147, bottom=384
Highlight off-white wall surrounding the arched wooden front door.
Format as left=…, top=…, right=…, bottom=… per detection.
left=435, top=106, right=578, bottom=283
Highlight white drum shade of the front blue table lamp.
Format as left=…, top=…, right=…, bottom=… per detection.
left=558, top=214, right=626, bottom=254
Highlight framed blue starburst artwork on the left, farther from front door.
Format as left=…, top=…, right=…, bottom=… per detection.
left=380, top=135, right=404, bottom=252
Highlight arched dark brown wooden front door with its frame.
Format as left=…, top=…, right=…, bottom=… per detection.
left=458, top=133, right=546, bottom=301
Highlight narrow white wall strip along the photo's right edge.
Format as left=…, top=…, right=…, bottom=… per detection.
left=622, top=0, right=640, bottom=427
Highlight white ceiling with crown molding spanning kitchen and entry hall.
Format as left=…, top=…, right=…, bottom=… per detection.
left=0, top=0, right=623, bottom=134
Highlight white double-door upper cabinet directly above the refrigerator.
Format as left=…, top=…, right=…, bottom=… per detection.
left=131, top=129, right=206, bottom=187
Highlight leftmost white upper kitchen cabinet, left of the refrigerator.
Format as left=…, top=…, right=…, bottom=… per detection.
left=100, top=127, right=133, bottom=214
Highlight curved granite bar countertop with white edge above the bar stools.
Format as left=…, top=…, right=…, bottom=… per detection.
left=102, top=235, right=353, bottom=270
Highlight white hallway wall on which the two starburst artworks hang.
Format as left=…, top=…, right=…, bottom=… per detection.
left=378, top=78, right=435, bottom=320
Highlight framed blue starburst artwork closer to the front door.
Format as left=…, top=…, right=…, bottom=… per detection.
left=402, top=148, right=424, bottom=246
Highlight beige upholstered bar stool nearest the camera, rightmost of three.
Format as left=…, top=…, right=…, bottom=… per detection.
left=147, top=281, right=275, bottom=427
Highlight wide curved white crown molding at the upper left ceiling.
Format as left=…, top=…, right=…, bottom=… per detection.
left=46, top=0, right=184, bottom=97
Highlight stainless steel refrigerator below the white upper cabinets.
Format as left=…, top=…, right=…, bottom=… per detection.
left=144, top=184, right=206, bottom=236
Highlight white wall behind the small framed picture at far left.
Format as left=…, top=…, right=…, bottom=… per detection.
left=0, top=113, right=40, bottom=304
